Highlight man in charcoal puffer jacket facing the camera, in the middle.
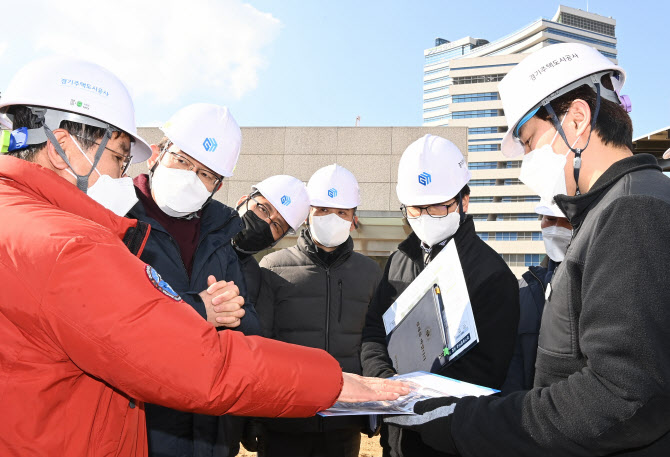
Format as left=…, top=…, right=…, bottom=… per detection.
left=257, top=164, right=381, bottom=457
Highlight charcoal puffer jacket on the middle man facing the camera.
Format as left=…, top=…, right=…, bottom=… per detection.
left=256, top=229, right=381, bottom=432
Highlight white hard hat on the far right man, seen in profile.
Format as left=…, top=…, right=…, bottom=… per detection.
left=498, top=43, right=627, bottom=157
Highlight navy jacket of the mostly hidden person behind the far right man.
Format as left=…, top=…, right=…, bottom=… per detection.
left=501, top=257, right=558, bottom=395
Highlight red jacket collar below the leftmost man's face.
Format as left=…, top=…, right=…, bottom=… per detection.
left=0, top=156, right=149, bottom=256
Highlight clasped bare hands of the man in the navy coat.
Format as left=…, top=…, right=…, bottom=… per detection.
left=199, top=275, right=245, bottom=328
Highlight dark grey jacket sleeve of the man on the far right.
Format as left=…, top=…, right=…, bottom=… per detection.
left=452, top=196, right=670, bottom=457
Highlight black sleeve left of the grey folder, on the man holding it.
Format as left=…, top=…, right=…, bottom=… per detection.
left=361, top=254, right=396, bottom=378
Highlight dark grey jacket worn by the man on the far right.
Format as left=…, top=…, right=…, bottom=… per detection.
left=452, top=151, right=670, bottom=457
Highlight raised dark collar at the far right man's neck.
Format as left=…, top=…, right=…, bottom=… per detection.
left=554, top=154, right=661, bottom=231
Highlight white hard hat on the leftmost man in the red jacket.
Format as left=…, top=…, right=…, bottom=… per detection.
left=0, top=57, right=151, bottom=163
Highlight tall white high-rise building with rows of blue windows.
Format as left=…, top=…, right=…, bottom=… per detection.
left=423, top=6, right=617, bottom=275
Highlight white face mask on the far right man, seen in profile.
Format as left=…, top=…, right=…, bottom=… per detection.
left=519, top=116, right=581, bottom=202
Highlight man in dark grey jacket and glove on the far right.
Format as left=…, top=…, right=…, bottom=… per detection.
left=391, top=43, right=670, bottom=457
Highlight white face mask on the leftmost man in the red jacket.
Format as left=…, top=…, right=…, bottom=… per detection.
left=65, top=135, right=138, bottom=216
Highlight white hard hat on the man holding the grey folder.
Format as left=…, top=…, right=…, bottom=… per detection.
left=396, top=135, right=471, bottom=205
